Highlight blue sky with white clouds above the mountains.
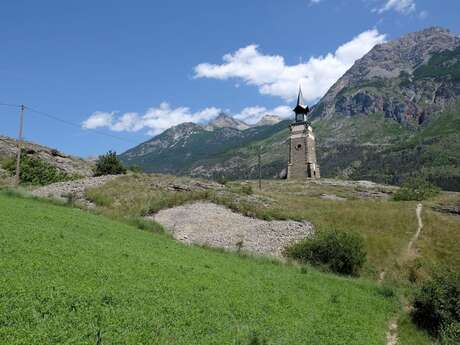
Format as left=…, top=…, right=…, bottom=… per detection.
left=0, top=0, right=460, bottom=156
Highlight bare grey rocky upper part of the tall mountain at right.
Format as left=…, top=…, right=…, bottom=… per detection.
left=314, top=28, right=460, bottom=125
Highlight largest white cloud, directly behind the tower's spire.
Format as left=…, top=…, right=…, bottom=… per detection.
left=195, top=29, right=385, bottom=102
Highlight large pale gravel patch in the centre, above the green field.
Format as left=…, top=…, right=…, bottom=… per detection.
left=153, top=202, right=313, bottom=256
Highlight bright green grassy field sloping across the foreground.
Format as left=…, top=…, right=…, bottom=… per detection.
left=0, top=194, right=395, bottom=345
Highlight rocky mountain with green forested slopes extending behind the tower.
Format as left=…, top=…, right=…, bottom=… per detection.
left=122, top=28, right=460, bottom=190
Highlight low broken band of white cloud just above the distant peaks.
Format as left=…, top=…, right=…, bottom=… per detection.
left=82, top=102, right=292, bottom=136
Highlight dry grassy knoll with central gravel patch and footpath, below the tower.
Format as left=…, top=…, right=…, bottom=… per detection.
left=33, top=174, right=460, bottom=345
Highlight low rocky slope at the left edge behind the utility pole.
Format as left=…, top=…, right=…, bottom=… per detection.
left=0, top=136, right=94, bottom=176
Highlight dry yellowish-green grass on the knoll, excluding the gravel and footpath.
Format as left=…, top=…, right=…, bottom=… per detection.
left=89, top=175, right=460, bottom=345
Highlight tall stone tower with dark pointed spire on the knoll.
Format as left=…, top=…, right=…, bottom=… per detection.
left=287, top=88, right=320, bottom=180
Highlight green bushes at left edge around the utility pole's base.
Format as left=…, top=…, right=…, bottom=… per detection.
left=3, top=153, right=75, bottom=185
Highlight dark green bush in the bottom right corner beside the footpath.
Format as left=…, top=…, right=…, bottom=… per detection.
left=412, top=272, right=460, bottom=338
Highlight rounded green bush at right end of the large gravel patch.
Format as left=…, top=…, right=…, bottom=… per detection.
left=285, top=230, right=367, bottom=275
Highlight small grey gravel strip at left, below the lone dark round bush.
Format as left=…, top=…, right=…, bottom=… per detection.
left=31, top=175, right=117, bottom=207
